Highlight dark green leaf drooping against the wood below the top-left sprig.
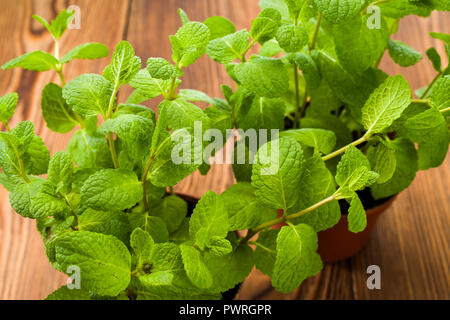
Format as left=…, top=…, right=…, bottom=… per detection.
left=41, top=83, right=78, bottom=133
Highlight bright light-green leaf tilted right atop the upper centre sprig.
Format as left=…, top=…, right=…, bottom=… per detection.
left=170, top=22, right=210, bottom=68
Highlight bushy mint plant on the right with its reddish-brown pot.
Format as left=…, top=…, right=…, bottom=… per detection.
left=203, top=0, right=450, bottom=264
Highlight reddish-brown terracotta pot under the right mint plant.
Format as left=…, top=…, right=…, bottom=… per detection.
left=317, top=195, right=397, bottom=262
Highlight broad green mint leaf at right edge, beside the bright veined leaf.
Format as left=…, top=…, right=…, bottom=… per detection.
left=400, top=107, right=449, bottom=170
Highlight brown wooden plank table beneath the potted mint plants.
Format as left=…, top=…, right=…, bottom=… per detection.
left=0, top=0, right=450, bottom=299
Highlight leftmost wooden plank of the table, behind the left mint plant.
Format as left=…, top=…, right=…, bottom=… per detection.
left=0, top=0, right=132, bottom=299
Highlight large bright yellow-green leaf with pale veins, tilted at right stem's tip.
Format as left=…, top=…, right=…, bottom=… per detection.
left=362, top=75, right=411, bottom=133
